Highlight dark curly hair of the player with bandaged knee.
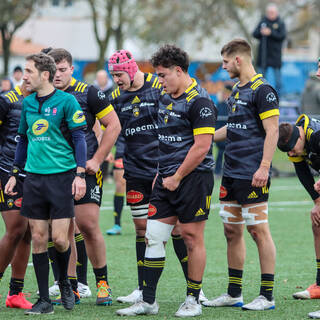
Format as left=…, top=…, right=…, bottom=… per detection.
left=150, top=44, right=189, bottom=72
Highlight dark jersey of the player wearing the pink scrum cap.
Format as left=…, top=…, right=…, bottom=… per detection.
left=109, top=73, right=161, bottom=180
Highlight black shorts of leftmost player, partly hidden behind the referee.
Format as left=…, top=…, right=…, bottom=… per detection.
left=0, top=170, right=24, bottom=212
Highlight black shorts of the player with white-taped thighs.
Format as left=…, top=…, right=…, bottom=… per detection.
left=219, top=177, right=270, bottom=204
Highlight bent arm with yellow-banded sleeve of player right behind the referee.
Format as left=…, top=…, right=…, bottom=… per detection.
left=86, top=87, right=121, bottom=174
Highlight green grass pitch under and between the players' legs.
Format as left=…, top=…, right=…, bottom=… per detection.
left=0, top=174, right=320, bottom=320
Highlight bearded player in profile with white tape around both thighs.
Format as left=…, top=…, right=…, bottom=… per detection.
left=204, top=39, right=279, bottom=310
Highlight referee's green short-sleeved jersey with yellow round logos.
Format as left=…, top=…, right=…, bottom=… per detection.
left=18, top=90, right=86, bottom=174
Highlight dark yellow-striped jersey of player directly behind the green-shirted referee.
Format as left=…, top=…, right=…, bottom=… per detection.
left=65, top=78, right=113, bottom=160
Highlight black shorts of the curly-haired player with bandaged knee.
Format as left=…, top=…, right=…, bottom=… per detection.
left=148, top=171, right=214, bottom=223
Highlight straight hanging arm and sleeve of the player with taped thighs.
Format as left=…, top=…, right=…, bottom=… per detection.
left=252, top=86, right=280, bottom=187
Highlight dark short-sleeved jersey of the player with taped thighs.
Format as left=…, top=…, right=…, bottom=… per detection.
left=223, top=74, right=279, bottom=180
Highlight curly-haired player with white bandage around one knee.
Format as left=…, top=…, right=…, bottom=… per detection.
left=114, top=45, right=217, bottom=317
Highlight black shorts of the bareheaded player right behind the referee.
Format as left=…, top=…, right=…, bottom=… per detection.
left=74, top=169, right=103, bottom=207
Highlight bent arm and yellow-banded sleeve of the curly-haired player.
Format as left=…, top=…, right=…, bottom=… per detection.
left=163, top=98, right=217, bottom=191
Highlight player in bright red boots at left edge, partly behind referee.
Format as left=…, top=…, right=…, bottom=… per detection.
left=0, top=84, right=32, bottom=309
